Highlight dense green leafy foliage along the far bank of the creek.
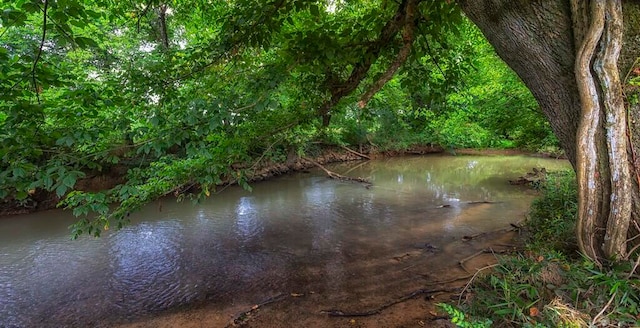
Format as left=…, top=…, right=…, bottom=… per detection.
left=0, top=0, right=556, bottom=236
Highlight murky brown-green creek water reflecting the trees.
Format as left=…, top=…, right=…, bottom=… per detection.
left=0, top=156, right=568, bottom=327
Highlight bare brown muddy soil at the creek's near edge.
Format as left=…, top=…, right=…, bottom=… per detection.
left=117, top=230, right=518, bottom=328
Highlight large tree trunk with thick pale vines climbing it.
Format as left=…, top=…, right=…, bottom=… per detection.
left=459, top=0, right=640, bottom=261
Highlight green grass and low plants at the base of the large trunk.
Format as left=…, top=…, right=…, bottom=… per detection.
left=440, top=172, right=640, bottom=328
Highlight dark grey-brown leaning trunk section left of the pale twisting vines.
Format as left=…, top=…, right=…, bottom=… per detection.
left=459, top=0, right=580, bottom=167
